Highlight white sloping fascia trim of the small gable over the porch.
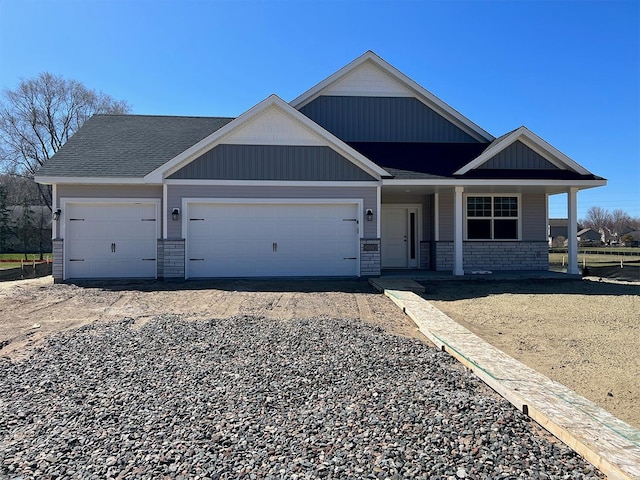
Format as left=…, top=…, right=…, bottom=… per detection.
left=454, top=126, right=591, bottom=175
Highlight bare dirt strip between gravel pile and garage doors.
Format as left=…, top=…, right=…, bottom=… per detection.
left=0, top=276, right=428, bottom=360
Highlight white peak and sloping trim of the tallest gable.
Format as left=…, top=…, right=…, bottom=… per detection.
left=291, top=51, right=494, bottom=142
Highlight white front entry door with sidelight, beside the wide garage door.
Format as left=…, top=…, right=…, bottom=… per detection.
left=381, top=206, right=418, bottom=268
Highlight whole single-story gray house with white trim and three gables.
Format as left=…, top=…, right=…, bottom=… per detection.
left=36, top=52, right=606, bottom=281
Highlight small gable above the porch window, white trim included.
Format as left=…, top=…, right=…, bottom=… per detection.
left=455, top=127, right=592, bottom=175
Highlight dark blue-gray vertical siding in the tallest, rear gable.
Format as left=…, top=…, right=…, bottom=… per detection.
left=300, top=96, right=477, bottom=143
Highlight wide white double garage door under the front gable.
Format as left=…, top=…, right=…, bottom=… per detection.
left=186, top=203, right=359, bottom=278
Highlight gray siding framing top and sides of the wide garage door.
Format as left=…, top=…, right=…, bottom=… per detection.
left=167, top=185, right=377, bottom=239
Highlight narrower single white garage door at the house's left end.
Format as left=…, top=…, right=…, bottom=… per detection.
left=64, top=203, right=158, bottom=278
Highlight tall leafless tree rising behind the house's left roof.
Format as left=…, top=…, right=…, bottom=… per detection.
left=0, top=72, right=131, bottom=208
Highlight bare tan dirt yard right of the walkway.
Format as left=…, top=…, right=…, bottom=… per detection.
left=423, top=280, right=640, bottom=428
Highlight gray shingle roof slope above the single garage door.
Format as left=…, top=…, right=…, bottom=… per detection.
left=37, top=115, right=233, bottom=178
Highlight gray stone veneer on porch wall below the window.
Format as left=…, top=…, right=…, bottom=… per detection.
left=435, top=241, right=549, bottom=272
